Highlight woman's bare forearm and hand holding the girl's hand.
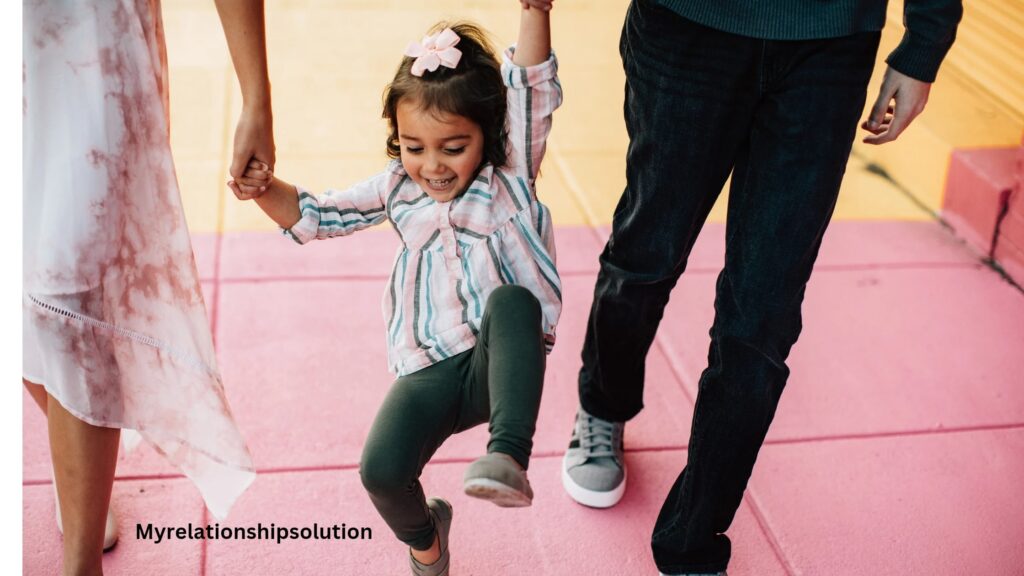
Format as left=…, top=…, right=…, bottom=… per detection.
left=216, top=0, right=276, bottom=200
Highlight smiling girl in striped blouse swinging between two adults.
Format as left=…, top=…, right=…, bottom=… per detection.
left=229, top=8, right=562, bottom=575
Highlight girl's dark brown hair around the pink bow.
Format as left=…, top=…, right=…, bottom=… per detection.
left=383, top=22, right=508, bottom=168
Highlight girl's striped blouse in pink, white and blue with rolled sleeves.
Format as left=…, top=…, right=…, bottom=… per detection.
left=285, top=49, right=562, bottom=376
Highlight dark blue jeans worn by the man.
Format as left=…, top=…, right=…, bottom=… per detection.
left=580, top=0, right=880, bottom=573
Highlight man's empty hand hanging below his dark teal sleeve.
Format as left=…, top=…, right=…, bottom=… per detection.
left=860, top=68, right=932, bottom=145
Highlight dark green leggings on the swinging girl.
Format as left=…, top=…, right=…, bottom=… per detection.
left=359, top=285, right=546, bottom=550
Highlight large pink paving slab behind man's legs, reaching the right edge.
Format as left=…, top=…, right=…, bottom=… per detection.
left=656, top=268, right=1024, bottom=441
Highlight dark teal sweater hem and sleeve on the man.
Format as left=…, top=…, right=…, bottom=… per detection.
left=657, top=0, right=964, bottom=82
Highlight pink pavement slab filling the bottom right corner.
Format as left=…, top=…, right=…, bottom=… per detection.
left=749, top=426, right=1024, bottom=576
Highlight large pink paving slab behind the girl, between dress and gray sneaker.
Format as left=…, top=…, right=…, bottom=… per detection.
left=218, top=276, right=692, bottom=469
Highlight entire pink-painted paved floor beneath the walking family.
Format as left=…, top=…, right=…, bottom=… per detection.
left=24, top=221, right=1024, bottom=576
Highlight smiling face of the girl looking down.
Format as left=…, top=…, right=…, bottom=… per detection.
left=395, top=100, right=483, bottom=202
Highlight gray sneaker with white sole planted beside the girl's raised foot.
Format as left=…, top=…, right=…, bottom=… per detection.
left=562, top=407, right=626, bottom=508
